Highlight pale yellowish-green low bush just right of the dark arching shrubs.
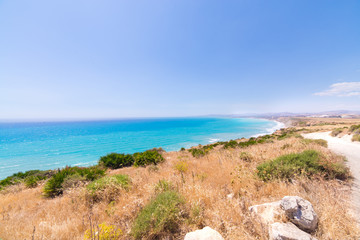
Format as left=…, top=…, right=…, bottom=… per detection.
left=86, top=174, right=131, bottom=202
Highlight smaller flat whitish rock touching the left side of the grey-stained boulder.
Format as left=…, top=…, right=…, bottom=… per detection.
left=249, top=201, right=285, bottom=225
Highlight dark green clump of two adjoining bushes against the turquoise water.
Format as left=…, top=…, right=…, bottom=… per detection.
left=99, top=148, right=164, bottom=169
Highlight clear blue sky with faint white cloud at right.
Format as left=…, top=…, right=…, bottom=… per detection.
left=0, top=0, right=360, bottom=119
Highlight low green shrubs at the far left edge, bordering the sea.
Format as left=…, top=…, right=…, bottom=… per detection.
left=0, top=170, right=53, bottom=190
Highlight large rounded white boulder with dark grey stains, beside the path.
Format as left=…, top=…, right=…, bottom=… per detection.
left=281, top=196, right=318, bottom=232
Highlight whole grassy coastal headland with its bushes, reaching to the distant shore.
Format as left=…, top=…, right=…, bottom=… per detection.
left=0, top=117, right=360, bottom=239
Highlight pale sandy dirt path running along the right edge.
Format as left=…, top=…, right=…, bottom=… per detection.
left=304, top=132, right=360, bottom=223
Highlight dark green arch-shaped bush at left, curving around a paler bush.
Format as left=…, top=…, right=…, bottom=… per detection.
left=43, top=166, right=105, bottom=197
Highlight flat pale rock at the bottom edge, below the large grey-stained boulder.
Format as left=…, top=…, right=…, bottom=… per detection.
left=269, top=222, right=316, bottom=240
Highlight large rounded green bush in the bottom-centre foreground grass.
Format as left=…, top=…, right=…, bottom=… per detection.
left=131, top=191, right=185, bottom=239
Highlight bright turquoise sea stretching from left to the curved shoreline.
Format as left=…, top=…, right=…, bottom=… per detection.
left=0, top=118, right=279, bottom=179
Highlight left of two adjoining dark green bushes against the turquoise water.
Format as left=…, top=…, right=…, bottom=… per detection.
left=99, top=153, right=134, bottom=169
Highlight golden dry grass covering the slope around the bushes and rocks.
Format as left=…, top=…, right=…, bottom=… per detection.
left=0, top=119, right=360, bottom=240
